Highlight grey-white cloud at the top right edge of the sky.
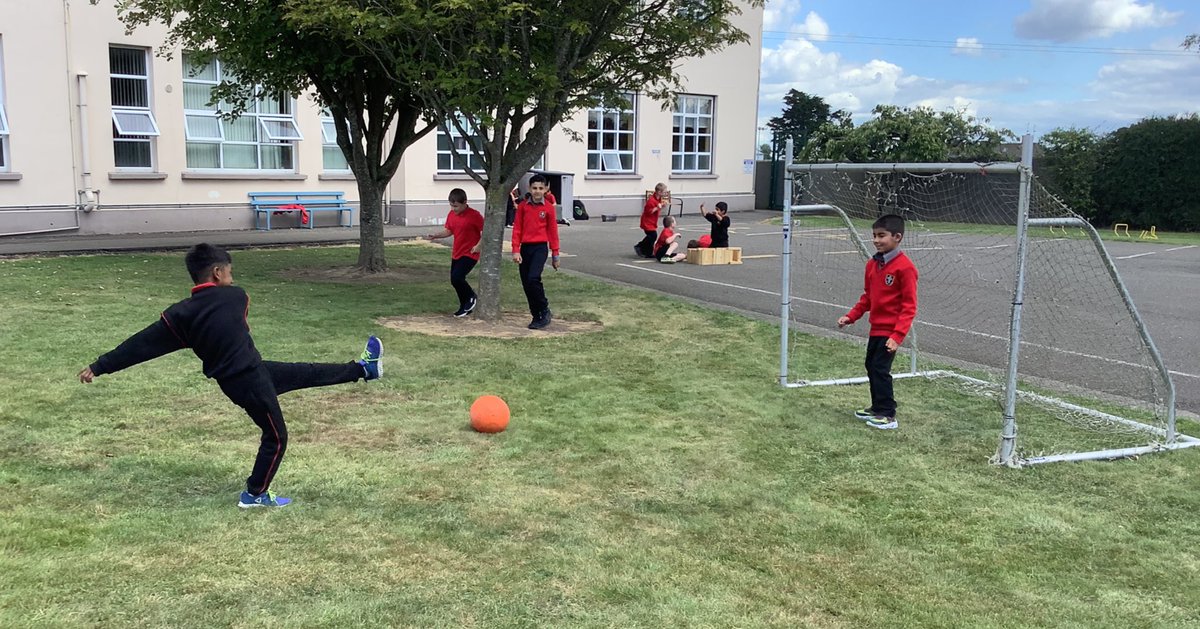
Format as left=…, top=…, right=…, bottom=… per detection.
left=1013, top=0, right=1182, bottom=42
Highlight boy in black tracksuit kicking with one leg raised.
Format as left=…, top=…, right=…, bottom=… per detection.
left=79, top=244, right=383, bottom=509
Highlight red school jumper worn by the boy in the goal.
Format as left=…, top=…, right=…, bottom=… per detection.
left=846, top=252, right=917, bottom=345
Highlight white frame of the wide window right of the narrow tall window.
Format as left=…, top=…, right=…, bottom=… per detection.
left=182, top=53, right=304, bottom=173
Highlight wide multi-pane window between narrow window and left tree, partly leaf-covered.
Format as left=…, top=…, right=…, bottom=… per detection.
left=184, top=53, right=304, bottom=170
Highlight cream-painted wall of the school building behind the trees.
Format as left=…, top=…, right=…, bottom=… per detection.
left=0, top=0, right=762, bottom=234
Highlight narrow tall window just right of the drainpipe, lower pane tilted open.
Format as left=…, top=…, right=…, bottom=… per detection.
left=108, top=46, right=158, bottom=168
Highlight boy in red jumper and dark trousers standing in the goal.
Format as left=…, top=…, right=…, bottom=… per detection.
left=838, top=214, right=917, bottom=430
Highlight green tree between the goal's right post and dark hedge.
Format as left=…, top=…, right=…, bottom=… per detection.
left=1037, top=127, right=1103, bottom=218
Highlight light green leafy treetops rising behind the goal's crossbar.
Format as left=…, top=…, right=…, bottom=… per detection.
left=800, top=104, right=1013, bottom=162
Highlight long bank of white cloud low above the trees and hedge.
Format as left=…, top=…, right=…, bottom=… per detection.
left=758, top=0, right=1200, bottom=134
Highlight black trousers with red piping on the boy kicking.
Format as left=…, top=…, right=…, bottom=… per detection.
left=218, top=360, right=364, bottom=495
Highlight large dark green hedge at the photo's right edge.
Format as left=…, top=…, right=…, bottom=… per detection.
left=1092, top=114, right=1200, bottom=232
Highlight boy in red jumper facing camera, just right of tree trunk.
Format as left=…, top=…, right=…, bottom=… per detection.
left=512, top=174, right=558, bottom=330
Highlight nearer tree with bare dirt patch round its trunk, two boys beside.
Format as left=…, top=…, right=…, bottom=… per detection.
left=304, top=0, right=762, bottom=321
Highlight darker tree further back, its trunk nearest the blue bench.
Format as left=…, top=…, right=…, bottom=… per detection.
left=111, top=0, right=438, bottom=272
